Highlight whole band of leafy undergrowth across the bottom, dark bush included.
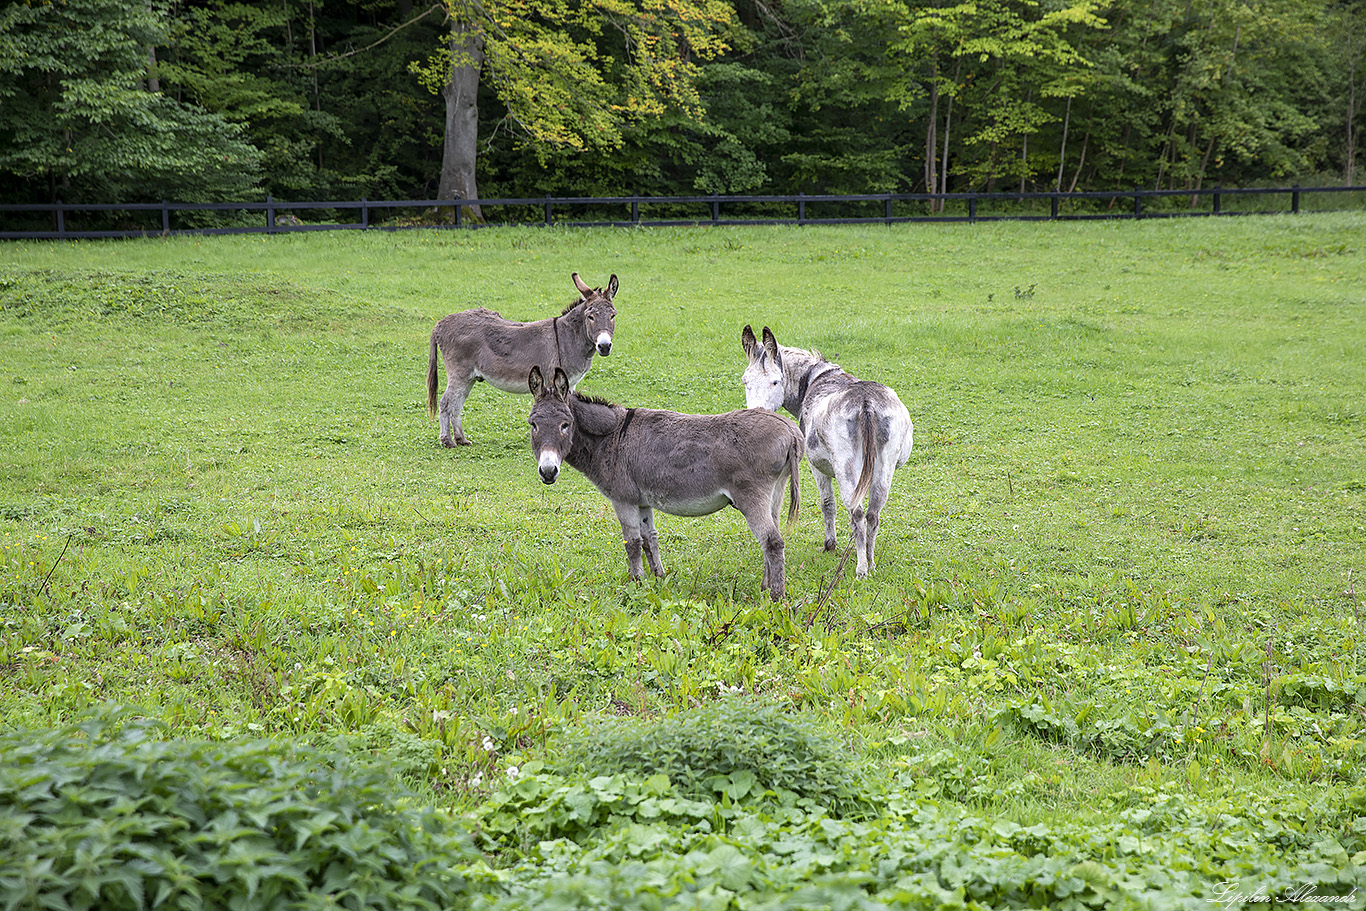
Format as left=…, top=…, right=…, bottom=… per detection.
left=0, top=702, right=1366, bottom=910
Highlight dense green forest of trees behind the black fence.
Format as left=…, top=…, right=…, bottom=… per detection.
left=0, top=0, right=1366, bottom=204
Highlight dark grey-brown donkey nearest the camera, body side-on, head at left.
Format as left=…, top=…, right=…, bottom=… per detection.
left=527, top=367, right=803, bottom=601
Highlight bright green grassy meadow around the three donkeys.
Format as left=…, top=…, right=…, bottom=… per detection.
left=0, top=213, right=1366, bottom=907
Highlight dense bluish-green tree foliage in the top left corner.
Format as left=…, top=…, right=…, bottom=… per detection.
left=0, top=0, right=260, bottom=202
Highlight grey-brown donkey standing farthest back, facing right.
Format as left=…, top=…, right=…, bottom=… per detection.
left=428, top=272, right=617, bottom=447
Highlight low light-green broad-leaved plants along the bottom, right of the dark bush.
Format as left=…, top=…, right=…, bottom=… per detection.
left=477, top=770, right=1366, bottom=908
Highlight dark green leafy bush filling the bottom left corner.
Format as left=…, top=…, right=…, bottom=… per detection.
left=0, top=713, right=477, bottom=910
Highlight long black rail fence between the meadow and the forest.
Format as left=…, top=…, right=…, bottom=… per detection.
left=0, top=186, right=1366, bottom=240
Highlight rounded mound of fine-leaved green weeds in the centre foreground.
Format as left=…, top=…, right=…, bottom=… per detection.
left=551, top=699, right=859, bottom=810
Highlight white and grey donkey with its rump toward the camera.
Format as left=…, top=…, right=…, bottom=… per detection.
left=740, top=326, right=912, bottom=579
